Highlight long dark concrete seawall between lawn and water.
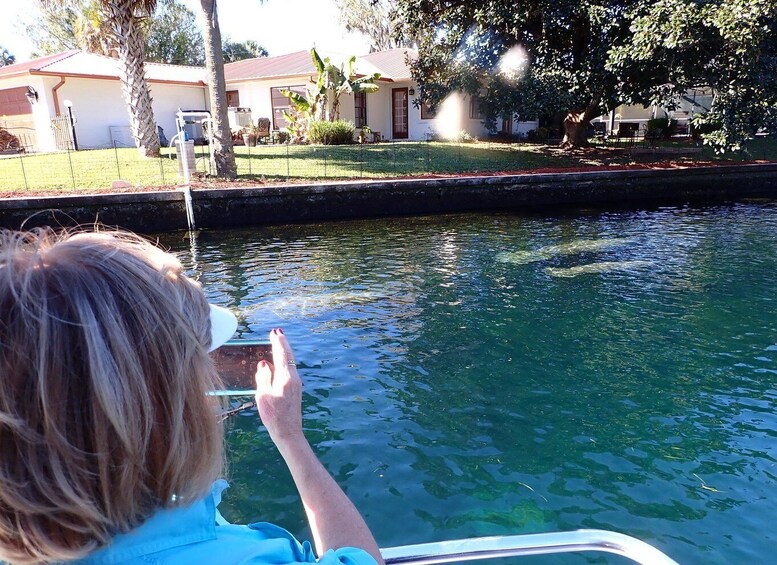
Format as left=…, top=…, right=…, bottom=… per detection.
left=0, top=164, right=777, bottom=232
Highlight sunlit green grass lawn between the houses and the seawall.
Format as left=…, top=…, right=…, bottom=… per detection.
left=0, top=139, right=777, bottom=195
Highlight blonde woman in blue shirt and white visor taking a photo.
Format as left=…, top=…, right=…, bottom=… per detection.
left=0, top=229, right=381, bottom=564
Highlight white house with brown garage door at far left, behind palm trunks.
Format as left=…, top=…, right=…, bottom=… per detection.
left=0, top=50, right=207, bottom=151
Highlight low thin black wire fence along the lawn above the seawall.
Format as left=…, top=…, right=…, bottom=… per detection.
left=0, top=138, right=554, bottom=192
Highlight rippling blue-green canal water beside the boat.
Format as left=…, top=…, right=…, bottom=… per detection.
left=165, top=203, right=777, bottom=563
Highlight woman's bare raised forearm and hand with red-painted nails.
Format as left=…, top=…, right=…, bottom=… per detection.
left=256, top=330, right=383, bottom=565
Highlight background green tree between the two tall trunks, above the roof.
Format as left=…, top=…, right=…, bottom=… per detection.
left=144, top=0, right=205, bottom=66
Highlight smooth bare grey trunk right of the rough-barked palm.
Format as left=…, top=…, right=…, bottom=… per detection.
left=200, top=0, right=237, bottom=179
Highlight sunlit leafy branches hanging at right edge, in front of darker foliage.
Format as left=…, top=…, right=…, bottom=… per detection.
left=609, top=0, right=777, bottom=150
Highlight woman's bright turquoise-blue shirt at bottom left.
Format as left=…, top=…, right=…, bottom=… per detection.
left=69, top=480, right=376, bottom=565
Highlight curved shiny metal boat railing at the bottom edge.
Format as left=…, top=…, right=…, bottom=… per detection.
left=380, top=530, right=677, bottom=565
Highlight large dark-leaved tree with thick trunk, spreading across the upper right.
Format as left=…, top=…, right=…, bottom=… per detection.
left=397, top=0, right=777, bottom=147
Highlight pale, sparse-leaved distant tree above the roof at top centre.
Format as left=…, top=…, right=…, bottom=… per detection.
left=337, top=0, right=415, bottom=51
